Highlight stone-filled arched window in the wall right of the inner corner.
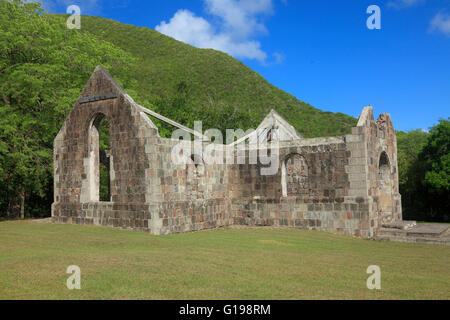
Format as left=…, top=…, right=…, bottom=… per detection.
left=281, top=154, right=309, bottom=197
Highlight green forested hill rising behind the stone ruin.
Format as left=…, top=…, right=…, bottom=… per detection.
left=59, top=15, right=356, bottom=137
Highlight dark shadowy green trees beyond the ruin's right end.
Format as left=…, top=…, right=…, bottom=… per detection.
left=398, top=120, right=450, bottom=222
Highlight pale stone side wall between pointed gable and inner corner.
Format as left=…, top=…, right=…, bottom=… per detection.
left=146, top=137, right=233, bottom=234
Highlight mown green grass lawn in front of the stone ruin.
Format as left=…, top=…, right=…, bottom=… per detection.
left=0, top=221, right=450, bottom=299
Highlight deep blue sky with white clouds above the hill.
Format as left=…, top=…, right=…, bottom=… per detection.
left=37, top=0, right=450, bottom=131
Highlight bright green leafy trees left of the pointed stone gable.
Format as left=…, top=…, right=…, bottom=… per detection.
left=0, top=0, right=132, bottom=215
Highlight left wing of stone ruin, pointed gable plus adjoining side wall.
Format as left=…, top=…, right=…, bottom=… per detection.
left=52, top=69, right=233, bottom=234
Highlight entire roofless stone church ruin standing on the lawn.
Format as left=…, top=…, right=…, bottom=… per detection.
left=52, top=67, right=402, bottom=238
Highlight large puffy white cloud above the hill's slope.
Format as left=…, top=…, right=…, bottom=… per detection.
left=155, top=0, right=281, bottom=63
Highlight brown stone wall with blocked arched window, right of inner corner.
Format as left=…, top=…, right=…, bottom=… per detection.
left=230, top=137, right=373, bottom=237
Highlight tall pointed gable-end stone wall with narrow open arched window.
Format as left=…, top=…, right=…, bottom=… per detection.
left=52, top=68, right=157, bottom=231
